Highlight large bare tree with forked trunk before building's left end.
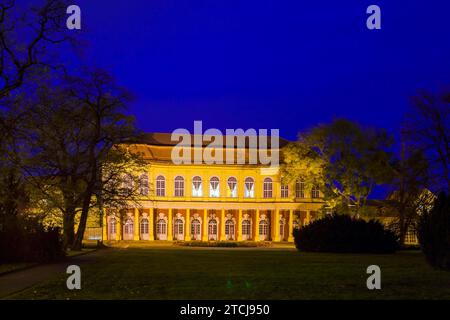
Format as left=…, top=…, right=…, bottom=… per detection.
left=23, top=71, right=141, bottom=249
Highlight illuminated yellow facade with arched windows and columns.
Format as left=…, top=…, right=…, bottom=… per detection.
left=103, top=133, right=323, bottom=242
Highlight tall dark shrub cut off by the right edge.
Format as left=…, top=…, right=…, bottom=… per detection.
left=417, top=193, right=450, bottom=270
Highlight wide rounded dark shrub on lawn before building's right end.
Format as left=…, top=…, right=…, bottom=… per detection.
left=294, top=214, right=398, bottom=253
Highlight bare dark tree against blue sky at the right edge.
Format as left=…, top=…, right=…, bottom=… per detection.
left=403, top=90, right=450, bottom=192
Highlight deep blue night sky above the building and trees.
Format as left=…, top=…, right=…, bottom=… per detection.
left=74, top=0, right=450, bottom=139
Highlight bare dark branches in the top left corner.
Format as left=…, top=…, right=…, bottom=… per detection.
left=0, top=0, right=69, bottom=100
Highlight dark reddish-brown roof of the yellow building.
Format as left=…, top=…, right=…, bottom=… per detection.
left=123, top=132, right=290, bottom=148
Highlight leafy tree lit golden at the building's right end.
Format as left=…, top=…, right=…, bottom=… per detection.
left=282, top=119, right=391, bottom=212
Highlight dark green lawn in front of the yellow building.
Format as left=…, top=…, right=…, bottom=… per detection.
left=7, top=248, right=450, bottom=299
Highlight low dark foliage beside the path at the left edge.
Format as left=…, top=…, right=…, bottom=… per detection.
left=0, top=221, right=65, bottom=262
